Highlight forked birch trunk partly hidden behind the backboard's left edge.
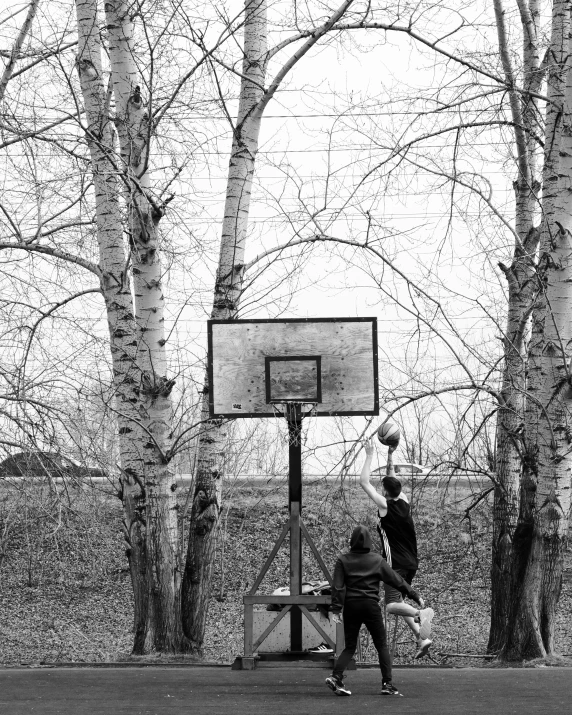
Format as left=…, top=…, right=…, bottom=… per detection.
left=182, top=0, right=353, bottom=653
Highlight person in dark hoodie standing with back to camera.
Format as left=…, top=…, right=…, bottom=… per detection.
left=326, top=524, right=424, bottom=695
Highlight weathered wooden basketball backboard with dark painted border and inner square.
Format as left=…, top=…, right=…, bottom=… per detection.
left=208, top=318, right=379, bottom=417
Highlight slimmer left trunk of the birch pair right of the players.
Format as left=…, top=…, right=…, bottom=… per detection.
left=488, top=0, right=541, bottom=653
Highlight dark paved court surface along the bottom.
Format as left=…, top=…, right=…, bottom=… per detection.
left=0, top=667, right=572, bottom=715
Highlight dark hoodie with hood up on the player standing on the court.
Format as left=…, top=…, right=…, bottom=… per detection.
left=331, top=524, right=419, bottom=613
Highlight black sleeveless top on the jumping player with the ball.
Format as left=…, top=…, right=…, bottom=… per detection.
left=377, top=499, right=419, bottom=570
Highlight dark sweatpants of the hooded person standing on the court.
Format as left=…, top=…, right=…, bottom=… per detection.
left=333, top=598, right=391, bottom=683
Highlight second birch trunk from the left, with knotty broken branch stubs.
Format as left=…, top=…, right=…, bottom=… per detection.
left=105, top=0, right=183, bottom=652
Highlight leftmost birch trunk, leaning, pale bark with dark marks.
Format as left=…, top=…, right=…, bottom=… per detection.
left=76, top=0, right=147, bottom=651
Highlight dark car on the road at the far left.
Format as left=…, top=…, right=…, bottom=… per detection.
left=0, top=451, right=105, bottom=480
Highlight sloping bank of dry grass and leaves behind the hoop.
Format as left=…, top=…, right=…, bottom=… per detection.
left=0, top=482, right=572, bottom=665
